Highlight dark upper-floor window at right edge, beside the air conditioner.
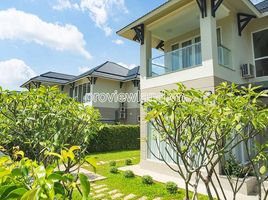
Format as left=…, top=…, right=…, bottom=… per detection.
left=253, top=29, right=268, bottom=77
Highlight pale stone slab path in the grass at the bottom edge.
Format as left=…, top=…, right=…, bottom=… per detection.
left=90, top=183, right=162, bottom=200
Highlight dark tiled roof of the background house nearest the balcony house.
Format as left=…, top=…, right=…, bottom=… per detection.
left=70, top=61, right=140, bottom=82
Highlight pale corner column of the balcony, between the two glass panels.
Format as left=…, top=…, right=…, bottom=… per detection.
left=200, top=4, right=218, bottom=76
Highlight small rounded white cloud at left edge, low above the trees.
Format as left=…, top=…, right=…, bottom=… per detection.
left=0, top=59, right=36, bottom=90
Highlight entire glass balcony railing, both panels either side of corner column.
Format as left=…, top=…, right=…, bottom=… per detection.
left=148, top=42, right=232, bottom=77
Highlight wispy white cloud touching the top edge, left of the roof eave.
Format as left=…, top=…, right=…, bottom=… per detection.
left=80, top=0, right=128, bottom=36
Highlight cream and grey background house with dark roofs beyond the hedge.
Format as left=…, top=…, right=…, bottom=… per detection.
left=21, top=62, right=140, bottom=124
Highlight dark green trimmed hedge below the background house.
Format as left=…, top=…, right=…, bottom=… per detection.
left=87, top=125, right=140, bottom=153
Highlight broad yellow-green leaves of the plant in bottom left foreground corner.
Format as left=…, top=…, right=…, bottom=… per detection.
left=0, top=146, right=95, bottom=200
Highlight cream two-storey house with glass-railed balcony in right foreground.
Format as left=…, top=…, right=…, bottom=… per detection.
left=117, top=0, right=268, bottom=195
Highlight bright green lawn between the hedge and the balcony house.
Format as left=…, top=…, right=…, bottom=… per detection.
left=82, top=151, right=207, bottom=200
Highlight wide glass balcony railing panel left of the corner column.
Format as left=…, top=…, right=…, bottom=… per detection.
left=148, top=42, right=202, bottom=77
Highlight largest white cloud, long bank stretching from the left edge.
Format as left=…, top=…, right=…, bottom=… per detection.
left=0, top=9, right=91, bottom=59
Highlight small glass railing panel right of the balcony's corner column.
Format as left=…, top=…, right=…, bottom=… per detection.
left=218, top=45, right=233, bottom=69
